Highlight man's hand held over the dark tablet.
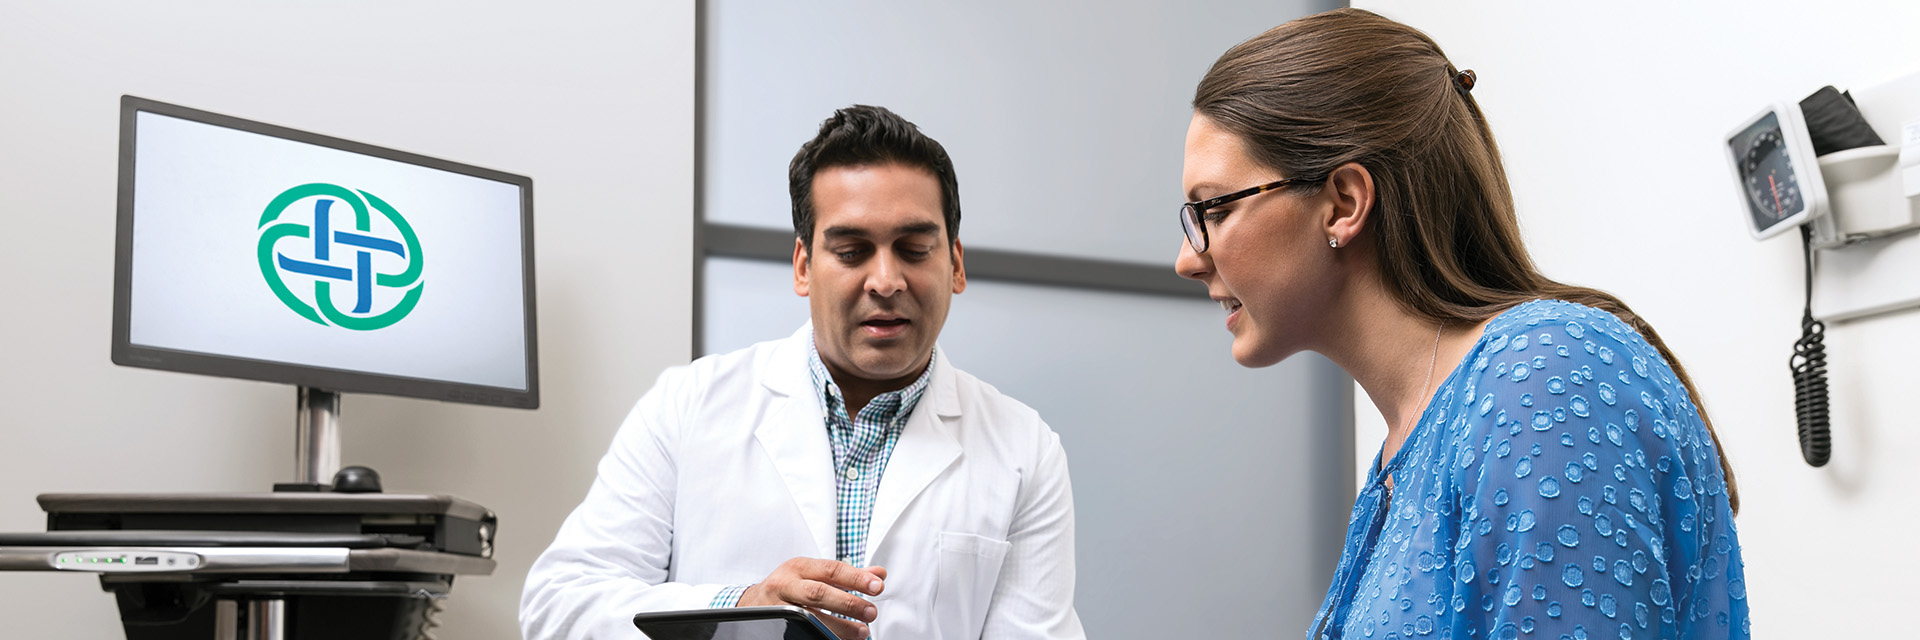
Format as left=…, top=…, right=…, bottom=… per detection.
left=735, top=557, right=887, bottom=640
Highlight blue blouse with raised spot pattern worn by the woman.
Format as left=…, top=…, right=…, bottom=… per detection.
left=1308, top=300, right=1747, bottom=640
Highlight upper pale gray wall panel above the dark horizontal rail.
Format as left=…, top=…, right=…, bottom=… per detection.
left=701, top=0, right=1338, bottom=265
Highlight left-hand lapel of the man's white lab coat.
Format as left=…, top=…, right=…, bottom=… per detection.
left=753, top=325, right=837, bottom=557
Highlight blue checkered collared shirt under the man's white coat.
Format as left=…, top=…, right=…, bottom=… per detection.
left=710, top=338, right=941, bottom=609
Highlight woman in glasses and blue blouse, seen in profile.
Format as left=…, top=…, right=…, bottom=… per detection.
left=1175, top=10, right=1747, bottom=638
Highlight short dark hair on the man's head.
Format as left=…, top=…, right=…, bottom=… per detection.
left=787, top=104, right=960, bottom=252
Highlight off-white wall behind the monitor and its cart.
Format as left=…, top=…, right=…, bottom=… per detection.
left=0, top=0, right=693, bottom=638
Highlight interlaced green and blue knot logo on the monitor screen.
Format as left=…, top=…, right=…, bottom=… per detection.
left=259, top=183, right=424, bottom=331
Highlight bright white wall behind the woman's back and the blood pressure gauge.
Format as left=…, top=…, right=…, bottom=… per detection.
left=1354, top=0, right=1920, bottom=638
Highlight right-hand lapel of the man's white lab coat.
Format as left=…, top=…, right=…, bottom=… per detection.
left=866, top=351, right=960, bottom=557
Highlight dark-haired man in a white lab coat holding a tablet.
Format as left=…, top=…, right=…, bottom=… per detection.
left=520, top=106, right=1085, bottom=640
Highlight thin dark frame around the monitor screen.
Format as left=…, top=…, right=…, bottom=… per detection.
left=113, top=96, right=540, bottom=409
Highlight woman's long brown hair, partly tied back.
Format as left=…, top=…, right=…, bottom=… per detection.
left=1194, top=10, right=1740, bottom=513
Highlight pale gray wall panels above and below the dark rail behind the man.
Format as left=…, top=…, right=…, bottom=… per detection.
left=695, top=0, right=1354, bottom=640
